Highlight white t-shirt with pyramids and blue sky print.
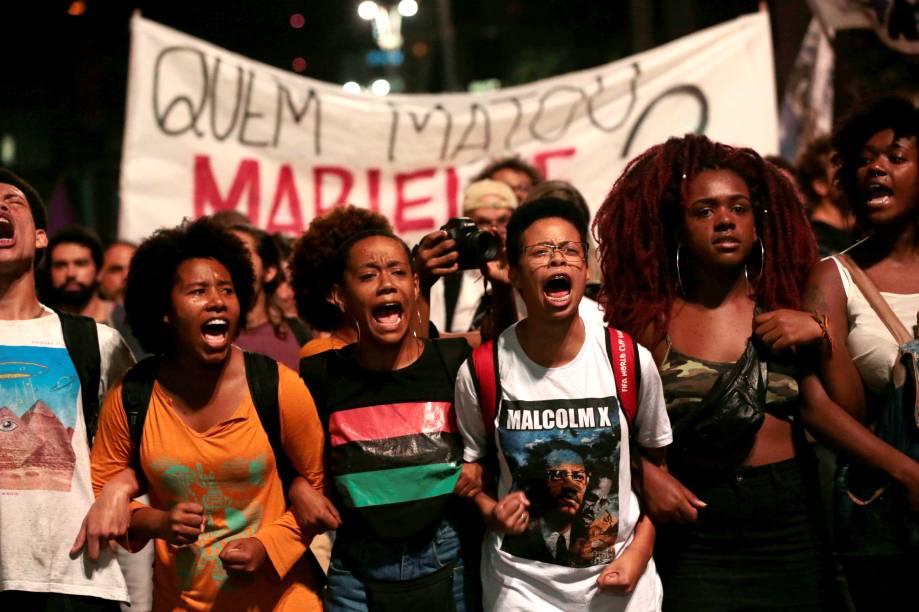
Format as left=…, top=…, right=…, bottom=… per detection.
left=0, top=310, right=134, bottom=601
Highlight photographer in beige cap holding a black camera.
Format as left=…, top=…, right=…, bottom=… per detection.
left=415, top=180, right=518, bottom=335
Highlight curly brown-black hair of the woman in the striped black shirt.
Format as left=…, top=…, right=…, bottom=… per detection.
left=290, top=206, right=392, bottom=331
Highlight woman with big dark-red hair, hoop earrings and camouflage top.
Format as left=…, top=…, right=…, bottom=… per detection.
left=594, top=135, right=919, bottom=611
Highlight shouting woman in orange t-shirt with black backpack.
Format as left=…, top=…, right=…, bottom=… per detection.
left=92, top=218, right=323, bottom=611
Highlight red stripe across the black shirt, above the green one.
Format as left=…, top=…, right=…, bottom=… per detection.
left=329, top=402, right=459, bottom=446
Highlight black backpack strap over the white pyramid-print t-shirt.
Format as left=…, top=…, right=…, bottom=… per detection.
left=57, top=311, right=102, bottom=446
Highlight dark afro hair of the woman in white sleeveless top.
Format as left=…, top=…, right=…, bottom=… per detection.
left=833, top=96, right=919, bottom=222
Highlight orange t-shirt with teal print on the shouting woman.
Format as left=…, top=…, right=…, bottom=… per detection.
left=92, top=365, right=323, bottom=612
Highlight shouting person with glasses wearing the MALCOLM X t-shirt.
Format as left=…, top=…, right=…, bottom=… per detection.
left=456, top=198, right=670, bottom=611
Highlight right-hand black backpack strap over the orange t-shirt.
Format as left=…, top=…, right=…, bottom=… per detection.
left=243, top=351, right=297, bottom=502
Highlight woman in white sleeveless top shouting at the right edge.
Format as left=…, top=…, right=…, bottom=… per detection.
left=807, top=97, right=919, bottom=610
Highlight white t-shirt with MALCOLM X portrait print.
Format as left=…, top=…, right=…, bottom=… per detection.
left=456, top=322, right=672, bottom=612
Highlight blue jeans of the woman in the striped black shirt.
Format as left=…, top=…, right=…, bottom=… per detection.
left=325, top=520, right=475, bottom=612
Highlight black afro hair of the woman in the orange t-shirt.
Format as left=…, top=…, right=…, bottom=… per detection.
left=124, top=217, right=255, bottom=355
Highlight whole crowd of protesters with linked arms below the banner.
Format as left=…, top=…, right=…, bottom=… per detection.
left=0, top=7, right=919, bottom=612
